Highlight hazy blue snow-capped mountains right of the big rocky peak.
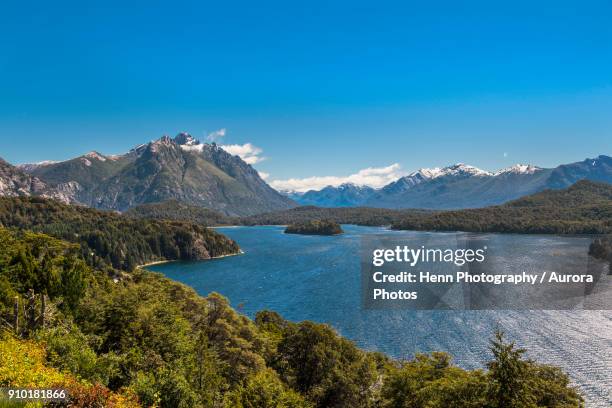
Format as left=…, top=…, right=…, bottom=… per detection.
left=292, top=155, right=612, bottom=209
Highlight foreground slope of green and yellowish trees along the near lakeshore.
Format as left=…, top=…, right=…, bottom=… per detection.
left=0, top=229, right=582, bottom=408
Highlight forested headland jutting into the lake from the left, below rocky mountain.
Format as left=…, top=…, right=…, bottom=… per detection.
left=0, top=197, right=239, bottom=271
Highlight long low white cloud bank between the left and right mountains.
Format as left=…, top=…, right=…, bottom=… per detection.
left=270, top=163, right=406, bottom=192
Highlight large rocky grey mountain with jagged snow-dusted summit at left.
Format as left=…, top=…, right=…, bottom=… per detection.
left=20, top=133, right=295, bottom=215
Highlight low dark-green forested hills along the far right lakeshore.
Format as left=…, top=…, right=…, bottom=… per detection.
left=245, top=180, right=612, bottom=234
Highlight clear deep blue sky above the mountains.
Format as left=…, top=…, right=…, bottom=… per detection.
left=0, top=1, right=612, bottom=183
